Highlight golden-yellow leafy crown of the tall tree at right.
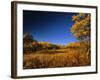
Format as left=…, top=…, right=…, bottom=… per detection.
left=71, top=13, right=91, bottom=40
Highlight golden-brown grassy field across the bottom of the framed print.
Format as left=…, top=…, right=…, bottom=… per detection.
left=23, top=48, right=91, bottom=69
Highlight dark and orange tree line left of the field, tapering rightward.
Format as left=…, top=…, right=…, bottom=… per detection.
left=23, top=33, right=62, bottom=53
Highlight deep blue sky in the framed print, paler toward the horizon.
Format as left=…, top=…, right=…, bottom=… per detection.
left=23, top=10, right=78, bottom=45
